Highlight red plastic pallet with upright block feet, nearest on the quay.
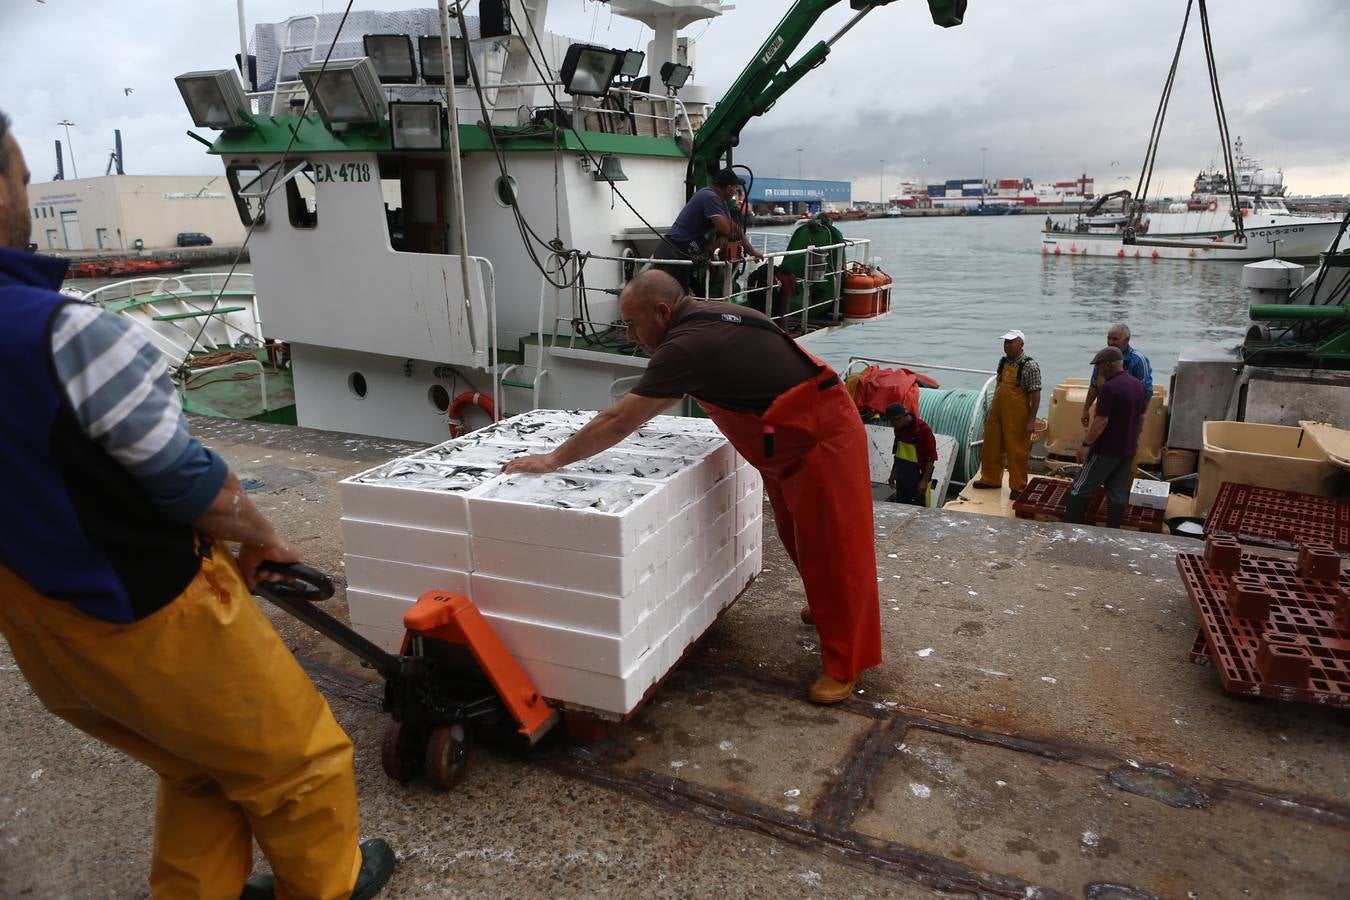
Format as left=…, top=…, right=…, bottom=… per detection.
left=1177, top=553, right=1350, bottom=707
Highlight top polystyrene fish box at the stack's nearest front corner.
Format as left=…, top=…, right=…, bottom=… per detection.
left=470, top=474, right=667, bottom=556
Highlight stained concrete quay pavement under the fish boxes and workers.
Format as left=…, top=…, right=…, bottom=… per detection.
left=0, top=420, right=1350, bottom=899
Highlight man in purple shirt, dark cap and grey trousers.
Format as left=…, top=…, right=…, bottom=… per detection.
left=1064, top=347, right=1148, bottom=528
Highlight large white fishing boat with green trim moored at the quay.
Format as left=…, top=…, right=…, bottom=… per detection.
left=163, top=0, right=959, bottom=441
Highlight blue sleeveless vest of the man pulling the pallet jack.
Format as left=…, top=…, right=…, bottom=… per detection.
left=0, top=247, right=201, bottom=623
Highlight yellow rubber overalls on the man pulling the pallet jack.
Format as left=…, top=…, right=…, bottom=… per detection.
left=0, top=544, right=360, bottom=900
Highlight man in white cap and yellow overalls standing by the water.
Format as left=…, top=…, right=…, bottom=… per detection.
left=975, top=328, right=1041, bottom=499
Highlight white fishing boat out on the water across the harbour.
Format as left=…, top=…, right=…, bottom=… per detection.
left=1041, top=138, right=1341, bottom=262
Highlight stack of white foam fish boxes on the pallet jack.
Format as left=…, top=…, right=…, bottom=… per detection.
left=340, top=410, right=764, bottom=715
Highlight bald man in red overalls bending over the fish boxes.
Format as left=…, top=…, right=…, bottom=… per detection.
left=504, top=270, right=882, bottom=703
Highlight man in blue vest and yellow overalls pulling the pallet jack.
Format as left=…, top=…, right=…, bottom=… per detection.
left=0, top=113, right=394, bottom=900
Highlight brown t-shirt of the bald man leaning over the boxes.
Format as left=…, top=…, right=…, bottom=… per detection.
left=633, top=297, right=815, bottom=414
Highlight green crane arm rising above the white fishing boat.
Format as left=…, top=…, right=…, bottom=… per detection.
left=684, top=0, right=967, bottom=196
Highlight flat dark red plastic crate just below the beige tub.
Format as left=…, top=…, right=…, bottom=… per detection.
left=1204, top=482, right=1350, bottom=556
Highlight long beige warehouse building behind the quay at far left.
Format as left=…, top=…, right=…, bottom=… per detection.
left=28, top=174, right=244, bottom=251
